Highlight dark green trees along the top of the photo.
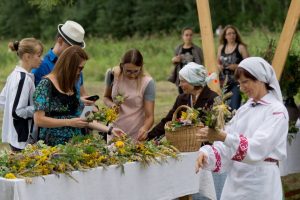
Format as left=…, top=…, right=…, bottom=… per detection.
left=0, top=0, right=290, bottom=39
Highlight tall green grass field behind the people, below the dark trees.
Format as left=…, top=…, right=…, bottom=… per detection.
left=0, top=29, right=300, bottom=83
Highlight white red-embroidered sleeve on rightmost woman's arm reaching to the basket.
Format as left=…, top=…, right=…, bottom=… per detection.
left=224, top=107, right=288, bottom=163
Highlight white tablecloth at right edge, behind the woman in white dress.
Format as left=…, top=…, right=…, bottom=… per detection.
left=279, top=119, right=300, bottom=176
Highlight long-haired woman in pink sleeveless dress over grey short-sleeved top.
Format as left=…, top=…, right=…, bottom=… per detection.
left=103, top=49, right=155, bottom=140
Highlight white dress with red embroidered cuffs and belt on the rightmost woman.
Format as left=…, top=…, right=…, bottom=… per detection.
left=200, top=93, right=289, bottom=200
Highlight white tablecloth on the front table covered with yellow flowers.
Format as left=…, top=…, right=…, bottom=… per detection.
left=0, top=152, right=215, bottom=200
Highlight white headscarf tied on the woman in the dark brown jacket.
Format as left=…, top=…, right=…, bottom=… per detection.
left=179, top=62, right=216, bottom=87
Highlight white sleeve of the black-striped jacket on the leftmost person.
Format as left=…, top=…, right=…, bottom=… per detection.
left=16, top=77, right=34, bottom=119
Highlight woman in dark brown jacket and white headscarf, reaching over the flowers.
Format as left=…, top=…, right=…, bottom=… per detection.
left=148, top=62, right=218, bottom=140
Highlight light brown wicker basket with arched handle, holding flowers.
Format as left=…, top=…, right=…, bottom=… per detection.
left=165, top=105, right=204, bottom=152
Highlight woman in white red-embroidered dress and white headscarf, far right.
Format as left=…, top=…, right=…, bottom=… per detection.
left=196, top=57, right=288, bottom=200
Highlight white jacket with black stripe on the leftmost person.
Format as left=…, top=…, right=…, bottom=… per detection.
left=0, top=66, right=35, bottom=149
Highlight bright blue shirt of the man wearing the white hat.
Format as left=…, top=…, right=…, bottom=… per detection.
left=32, top=49, right=83, bottom=92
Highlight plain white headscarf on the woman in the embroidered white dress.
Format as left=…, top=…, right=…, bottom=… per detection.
left=238, top=57, right=282, bottom=102
